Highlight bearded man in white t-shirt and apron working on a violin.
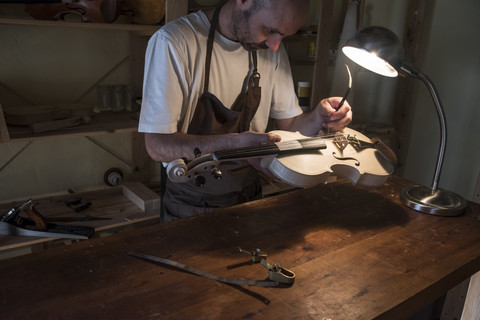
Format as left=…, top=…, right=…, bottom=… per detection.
left=139, top=0, right=352, bottom=221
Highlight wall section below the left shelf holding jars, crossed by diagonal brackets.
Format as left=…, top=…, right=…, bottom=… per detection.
left=0, top=133, right=131, bottom=202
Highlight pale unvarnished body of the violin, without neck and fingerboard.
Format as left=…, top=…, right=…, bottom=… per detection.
left=261, top=128, right=394, bottom=188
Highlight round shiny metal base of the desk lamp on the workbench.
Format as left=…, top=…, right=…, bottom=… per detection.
left=401, top=186, right=467, bottom=217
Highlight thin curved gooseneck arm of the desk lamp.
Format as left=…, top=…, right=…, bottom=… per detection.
left=400, top=59, right=447, bottom=191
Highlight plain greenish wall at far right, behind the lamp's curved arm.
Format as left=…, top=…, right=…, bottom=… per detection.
left=404, top=0, right=480, bottom=200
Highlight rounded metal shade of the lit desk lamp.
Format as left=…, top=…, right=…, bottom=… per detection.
left=342, top=26, right=405, bottom=77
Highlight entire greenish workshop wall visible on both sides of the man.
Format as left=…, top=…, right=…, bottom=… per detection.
left=0, top=0, right=480, bottom=202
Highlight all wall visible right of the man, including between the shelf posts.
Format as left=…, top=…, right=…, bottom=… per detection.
left=353, top=0, right=480, bottom=200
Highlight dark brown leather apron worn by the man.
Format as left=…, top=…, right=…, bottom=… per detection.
left=163, top=6, right=261, bottom=221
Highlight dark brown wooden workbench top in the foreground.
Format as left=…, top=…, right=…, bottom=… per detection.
left=0, top=177, right=480, bottom=320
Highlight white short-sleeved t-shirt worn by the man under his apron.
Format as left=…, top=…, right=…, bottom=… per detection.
left=138, top=11, right=302, bottom=133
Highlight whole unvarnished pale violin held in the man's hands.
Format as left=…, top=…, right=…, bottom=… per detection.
left=166, top=128, right=397, bottom=188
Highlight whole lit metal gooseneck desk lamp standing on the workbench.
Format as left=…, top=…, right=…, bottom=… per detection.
left=342, top=26, right=467, bottom=216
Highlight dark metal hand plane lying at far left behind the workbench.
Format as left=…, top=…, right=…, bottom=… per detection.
left=0, top=199, right=95, bottom=239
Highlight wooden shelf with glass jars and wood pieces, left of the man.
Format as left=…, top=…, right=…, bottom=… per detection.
left=3, top=112, right=138, bottom=142
